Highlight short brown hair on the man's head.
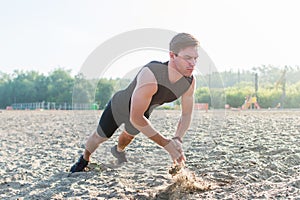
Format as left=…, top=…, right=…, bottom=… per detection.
left=169, top=33, right=199, bottom=54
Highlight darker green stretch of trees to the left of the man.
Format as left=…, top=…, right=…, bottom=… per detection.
left=0, top=68, right=129, bottom=109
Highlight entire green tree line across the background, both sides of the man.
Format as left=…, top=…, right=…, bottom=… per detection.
left=0, top=65, right=300, bottom=109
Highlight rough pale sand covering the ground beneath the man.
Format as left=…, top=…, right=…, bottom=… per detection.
left=0, top=110, right=300, bottom=199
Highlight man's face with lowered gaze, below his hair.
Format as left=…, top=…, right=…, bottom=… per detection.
left=174, top=46, right=198, bottom=77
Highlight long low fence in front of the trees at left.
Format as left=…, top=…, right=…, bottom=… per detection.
left=6, top=102, right=98, bottom=110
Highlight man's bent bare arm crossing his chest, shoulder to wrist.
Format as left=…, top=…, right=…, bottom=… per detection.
left=130, top=68, right=170, bottom=147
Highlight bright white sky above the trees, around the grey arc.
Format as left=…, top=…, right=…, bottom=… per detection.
left=0, top=0, right=300, bottom=77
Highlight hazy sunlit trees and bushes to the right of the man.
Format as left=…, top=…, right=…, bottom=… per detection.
left=195, top=65, right=300, bottom=108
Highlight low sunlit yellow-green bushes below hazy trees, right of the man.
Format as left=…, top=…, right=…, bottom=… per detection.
left=195, top=82, right=300, bottom=108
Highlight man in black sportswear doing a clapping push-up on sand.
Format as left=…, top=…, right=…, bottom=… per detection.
left=71, top=33, right=199, bottom=173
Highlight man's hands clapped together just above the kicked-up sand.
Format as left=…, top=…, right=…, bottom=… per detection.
left=164, top=138, right=185, bottom=164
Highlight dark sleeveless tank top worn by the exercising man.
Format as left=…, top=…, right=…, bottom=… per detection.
left=111, top=61, right=194, bottom=118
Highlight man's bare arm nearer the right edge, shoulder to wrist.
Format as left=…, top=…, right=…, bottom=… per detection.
left=174, top=77, right=196, bottom=142
